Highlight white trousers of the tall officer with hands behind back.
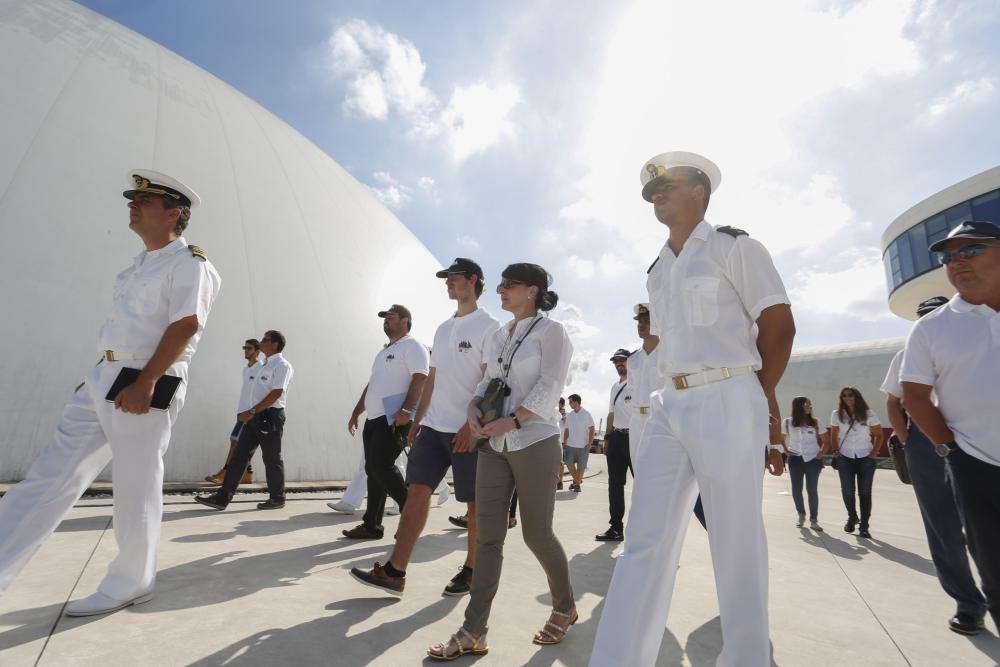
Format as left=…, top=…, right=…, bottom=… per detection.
left=590, top=374, right=771, bottom=667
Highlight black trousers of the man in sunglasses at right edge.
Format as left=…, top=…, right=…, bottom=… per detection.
left=947, top=451, right=1000, bottom=626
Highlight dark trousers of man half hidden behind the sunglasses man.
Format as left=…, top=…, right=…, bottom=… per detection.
left=903, top=424, right=986, bottom=618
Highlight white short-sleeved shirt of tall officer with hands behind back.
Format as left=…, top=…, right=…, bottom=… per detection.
left=646, top=220, right=789, bottom=380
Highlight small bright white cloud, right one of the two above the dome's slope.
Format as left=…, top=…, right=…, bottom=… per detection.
left=441, top=82, right=521, bottom=161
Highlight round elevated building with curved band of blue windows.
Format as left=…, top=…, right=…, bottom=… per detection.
left=882, top=166, right=1000, bottom=320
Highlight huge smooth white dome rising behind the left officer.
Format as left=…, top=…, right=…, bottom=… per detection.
left=0, top=0, right=451, bottom=481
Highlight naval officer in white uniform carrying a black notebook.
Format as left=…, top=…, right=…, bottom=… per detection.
left=0, top=169, right=221, bottom=616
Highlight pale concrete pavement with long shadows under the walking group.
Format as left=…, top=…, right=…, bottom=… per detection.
left=0, top=468, right=1000, bottom=667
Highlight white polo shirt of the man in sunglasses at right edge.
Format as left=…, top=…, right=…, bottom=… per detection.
left=900, top=295, right=1000, bottom=466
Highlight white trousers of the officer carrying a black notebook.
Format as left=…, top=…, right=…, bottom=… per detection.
left=0, top=361, right=187, bottom=600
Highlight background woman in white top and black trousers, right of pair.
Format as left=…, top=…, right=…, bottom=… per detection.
left=830, top=387, right=882, bottom=539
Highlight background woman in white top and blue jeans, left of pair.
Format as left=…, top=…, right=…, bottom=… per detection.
left=781, top=396, right=829, bottom=533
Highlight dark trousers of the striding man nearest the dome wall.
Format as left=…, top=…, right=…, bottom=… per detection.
left=219, top=408, right=285, bottom=502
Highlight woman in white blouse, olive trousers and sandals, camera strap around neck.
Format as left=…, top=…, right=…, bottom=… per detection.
left=427, top=264, right=577, bottom=660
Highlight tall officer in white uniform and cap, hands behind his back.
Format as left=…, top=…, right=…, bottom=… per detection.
left=590, top=152, right=795, bottom=667
